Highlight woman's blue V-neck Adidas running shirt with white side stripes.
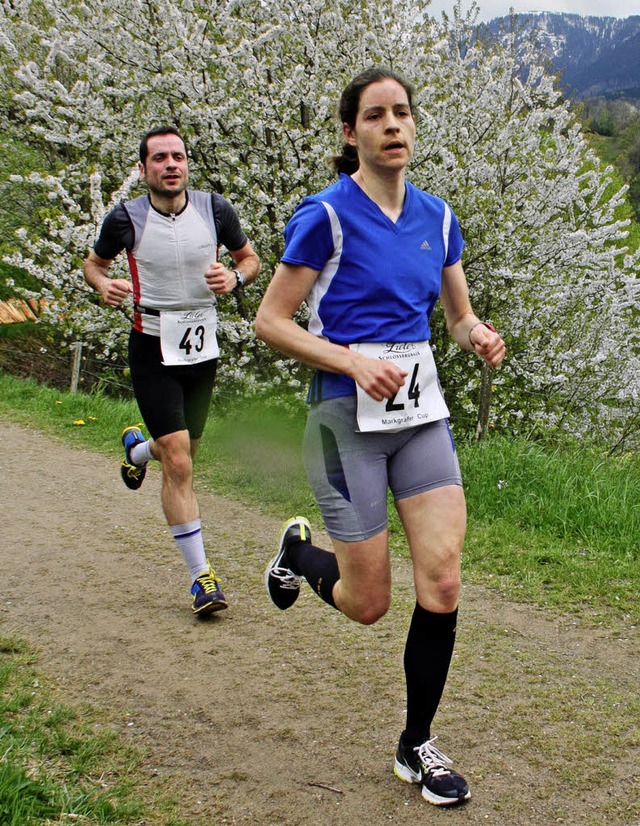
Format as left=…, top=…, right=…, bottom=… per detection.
left=282, top=174, right=464, bottom=401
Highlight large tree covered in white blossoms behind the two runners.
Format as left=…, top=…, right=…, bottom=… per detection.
left=0, top=0, right=640, bottom=446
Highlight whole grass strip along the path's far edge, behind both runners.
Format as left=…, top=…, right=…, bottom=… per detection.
left=0, top=366, right=640, bottom=626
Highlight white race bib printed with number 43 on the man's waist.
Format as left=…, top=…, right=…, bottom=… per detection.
left=160, top=307, right=220, bottom=366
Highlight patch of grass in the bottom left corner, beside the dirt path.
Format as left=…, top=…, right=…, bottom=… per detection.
left=0, top=637, right=190, bottom=826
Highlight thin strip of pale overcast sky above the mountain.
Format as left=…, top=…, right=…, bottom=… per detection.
left=429, top=0, right=640, bottom=21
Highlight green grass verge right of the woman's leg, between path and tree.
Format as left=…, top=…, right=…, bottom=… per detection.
left=461, top=439, right=640, bottom=623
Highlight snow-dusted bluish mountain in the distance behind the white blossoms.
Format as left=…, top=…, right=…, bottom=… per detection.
left=480, top=12, right=640, bottom=98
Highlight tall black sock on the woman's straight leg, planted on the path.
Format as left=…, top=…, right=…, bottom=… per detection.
left=402, top=602, right=458, bottom=748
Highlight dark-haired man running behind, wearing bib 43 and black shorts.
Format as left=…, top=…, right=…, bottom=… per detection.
left=84, top=126, right=260, bottom=616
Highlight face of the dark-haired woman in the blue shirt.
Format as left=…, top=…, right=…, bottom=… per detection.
left=342, top=78, right=416, bottom=172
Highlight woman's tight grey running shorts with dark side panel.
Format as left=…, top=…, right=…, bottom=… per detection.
left=303, top=396, right=462, bottom=542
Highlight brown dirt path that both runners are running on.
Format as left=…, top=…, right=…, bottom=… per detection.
left=0, top=423, right=640, bottom=826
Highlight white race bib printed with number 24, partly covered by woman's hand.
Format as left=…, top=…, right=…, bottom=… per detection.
left=350, top=341, right=449, bottom=432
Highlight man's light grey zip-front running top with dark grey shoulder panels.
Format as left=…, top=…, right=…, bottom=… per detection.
left=124, top=190, right=218, bottom=336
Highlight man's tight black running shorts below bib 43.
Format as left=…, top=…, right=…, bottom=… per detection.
left=129, top=330, right=218, bottom=439
